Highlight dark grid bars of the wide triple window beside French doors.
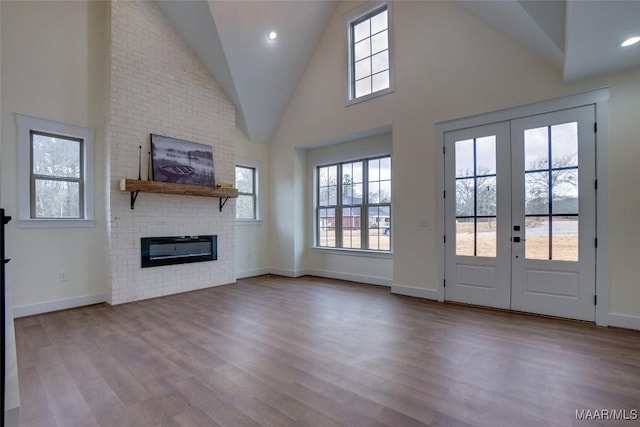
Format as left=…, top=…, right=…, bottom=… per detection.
left=315, top=155, right=393, bottom=252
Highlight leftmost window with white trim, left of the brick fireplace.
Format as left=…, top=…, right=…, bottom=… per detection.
left=17, top=115, right=94, bottom=227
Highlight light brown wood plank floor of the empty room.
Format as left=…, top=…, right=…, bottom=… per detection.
left=15, top=276, right=640, bottom=427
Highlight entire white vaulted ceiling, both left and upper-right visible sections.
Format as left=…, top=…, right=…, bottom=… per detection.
left=157, top=0, right=640, bottom=143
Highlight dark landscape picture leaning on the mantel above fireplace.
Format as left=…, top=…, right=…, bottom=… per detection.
left=151, top=134, right=215, bottom=187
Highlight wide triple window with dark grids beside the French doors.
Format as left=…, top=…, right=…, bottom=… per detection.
left=316, top=156, right=391, bottom=251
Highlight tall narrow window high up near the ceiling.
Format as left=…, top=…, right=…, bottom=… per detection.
left=349, top=4, right=391, bottom=100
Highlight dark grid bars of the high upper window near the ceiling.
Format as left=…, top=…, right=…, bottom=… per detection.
left=349, top=5, right=391, bottom=99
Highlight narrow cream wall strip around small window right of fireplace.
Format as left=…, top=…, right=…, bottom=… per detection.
left=236, top=128, right=271, bottom=278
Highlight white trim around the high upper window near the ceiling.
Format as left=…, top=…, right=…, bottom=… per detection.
left=343, top=1, right=395, bottom=106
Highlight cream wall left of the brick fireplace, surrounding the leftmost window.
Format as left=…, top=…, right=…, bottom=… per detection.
left=0, top=2, right=106, bottom=313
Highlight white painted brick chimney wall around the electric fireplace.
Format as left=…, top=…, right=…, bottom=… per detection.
left=107, top=1, right=235, bottom=304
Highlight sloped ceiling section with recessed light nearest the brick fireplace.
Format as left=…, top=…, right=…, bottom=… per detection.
left=158, top=0, right=335, bottom=143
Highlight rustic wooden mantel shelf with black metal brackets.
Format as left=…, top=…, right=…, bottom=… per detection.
left=120, top=178, right=238, bottom=211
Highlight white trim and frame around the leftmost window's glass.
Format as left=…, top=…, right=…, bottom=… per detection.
left=16, top=114, right=95, bottom=228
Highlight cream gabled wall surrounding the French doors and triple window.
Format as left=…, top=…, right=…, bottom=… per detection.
left=270, top=2, right=640, bottom=327
